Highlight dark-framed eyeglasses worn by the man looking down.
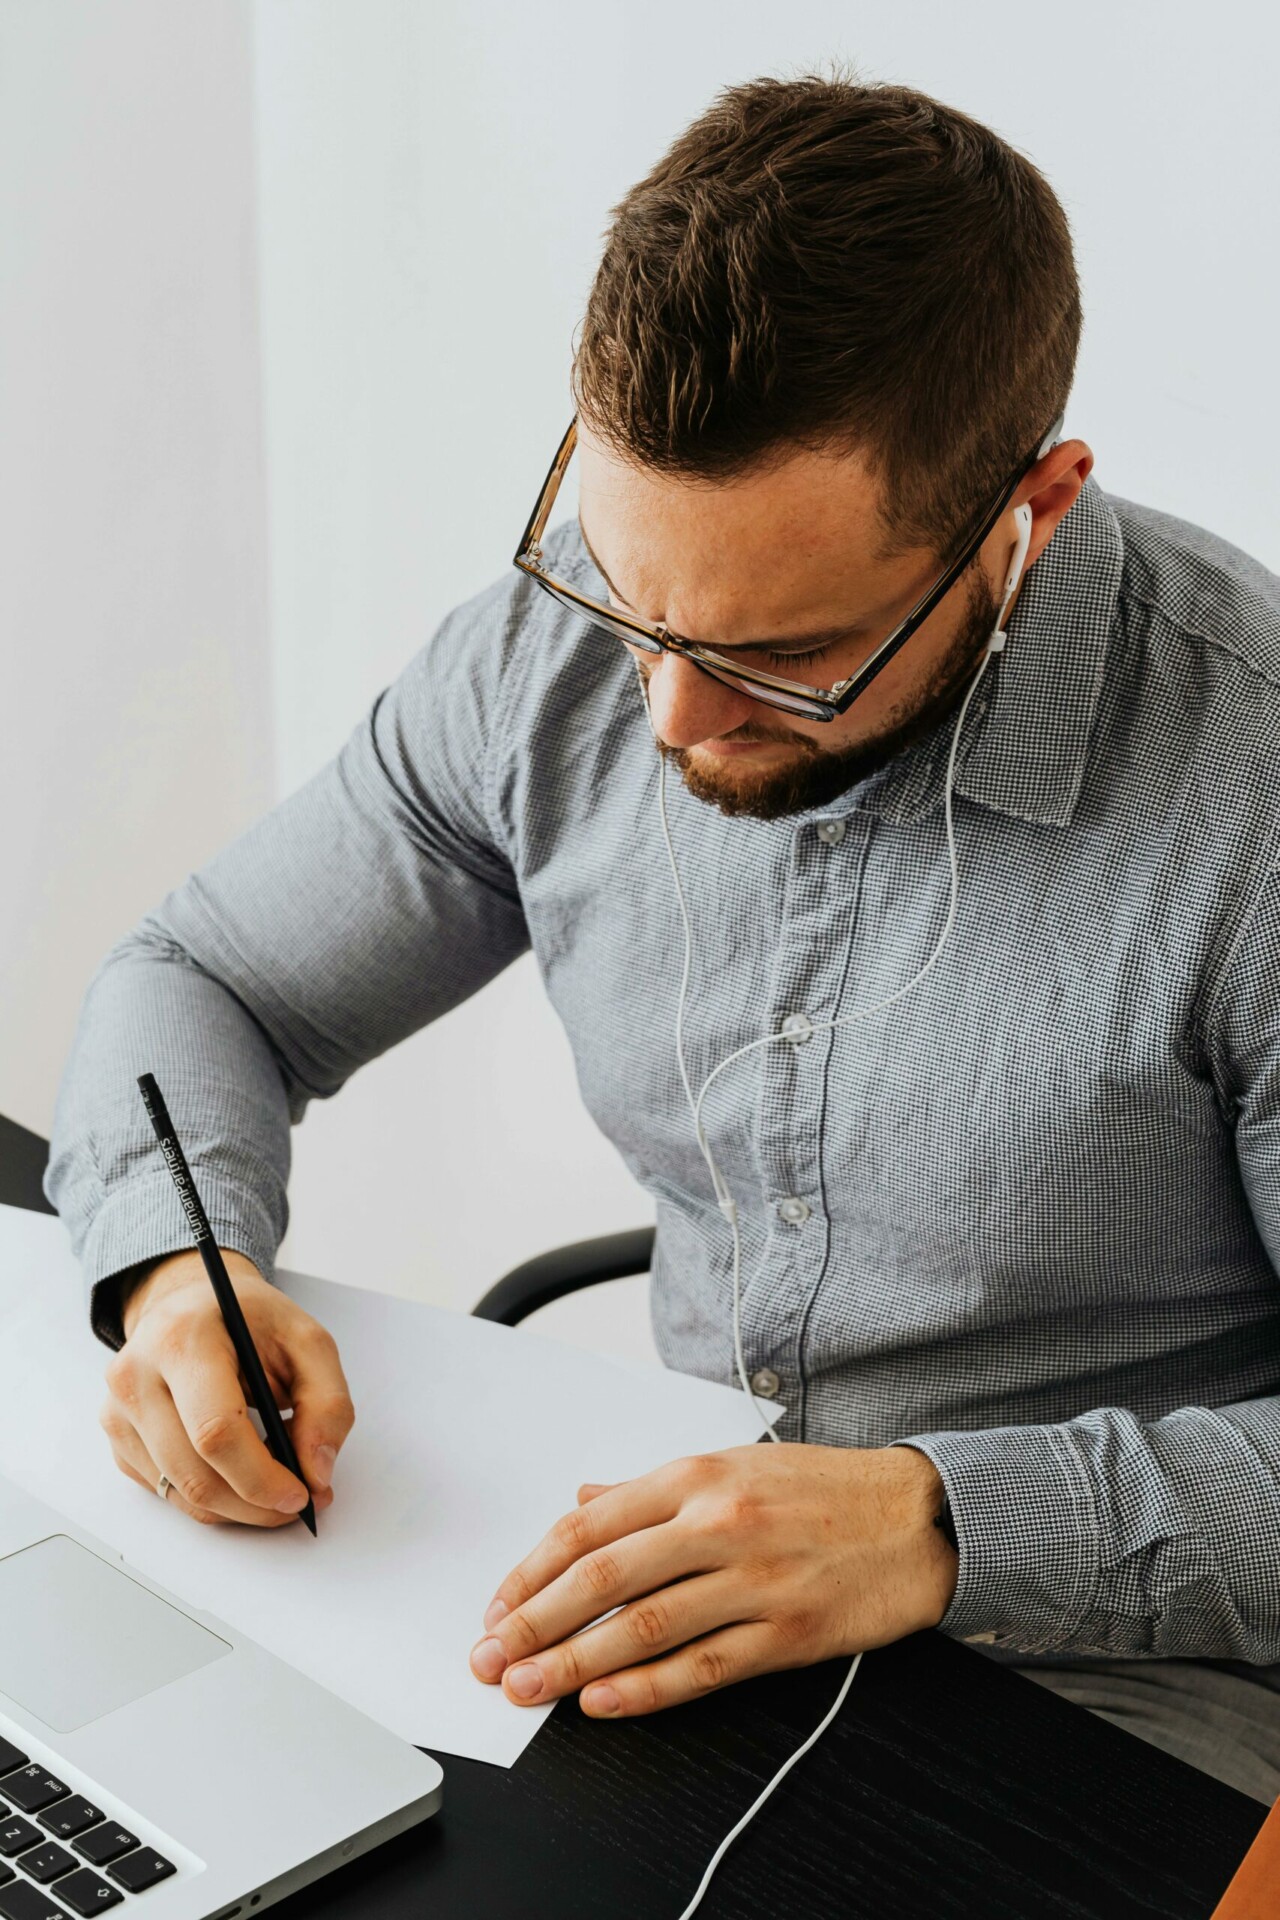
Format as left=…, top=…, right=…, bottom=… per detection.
left=512, top=413, right=1065, bottom=720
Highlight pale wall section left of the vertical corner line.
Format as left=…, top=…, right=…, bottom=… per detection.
left=0, top=0, right=274, bottom=1135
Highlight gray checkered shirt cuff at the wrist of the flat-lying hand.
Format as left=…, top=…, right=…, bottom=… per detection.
left=894, top=1427, right=1102, bottom=1653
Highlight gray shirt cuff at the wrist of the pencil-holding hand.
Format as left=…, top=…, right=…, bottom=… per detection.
left=81, top=1169, right=276, bottom=1352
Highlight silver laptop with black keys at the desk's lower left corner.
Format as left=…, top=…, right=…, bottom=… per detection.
left=0, top=1475, right=441, bottom=1920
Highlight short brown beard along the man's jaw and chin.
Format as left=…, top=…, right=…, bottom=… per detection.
left=658, top=568, right=1000, bottom=820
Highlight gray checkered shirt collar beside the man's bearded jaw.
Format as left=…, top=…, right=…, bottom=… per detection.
left=855, top=480, right=1125, bottom=826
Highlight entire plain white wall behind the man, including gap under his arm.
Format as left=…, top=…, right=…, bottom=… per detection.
left=0, top=0, right=1280, bottom=1350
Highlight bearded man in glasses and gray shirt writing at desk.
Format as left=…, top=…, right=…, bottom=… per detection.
left=46, top=60, right=1280, bottom=1801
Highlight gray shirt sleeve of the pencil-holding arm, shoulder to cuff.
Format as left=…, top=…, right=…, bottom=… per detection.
left=44, top=580, right=528, bottom=1346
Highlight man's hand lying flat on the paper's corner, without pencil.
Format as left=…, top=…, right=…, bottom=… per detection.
left=470, top=1442, right=958, bottom=1718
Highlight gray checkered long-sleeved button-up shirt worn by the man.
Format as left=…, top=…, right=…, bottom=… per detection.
left=46, top=482, right=1280, bottom=1663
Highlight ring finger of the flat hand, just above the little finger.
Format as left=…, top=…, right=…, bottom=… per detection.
left=487, top=1571, right=743, bottom=1705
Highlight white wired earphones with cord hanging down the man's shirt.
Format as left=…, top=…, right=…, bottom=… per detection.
left=635, top=505, right=1032, bottom=1920
